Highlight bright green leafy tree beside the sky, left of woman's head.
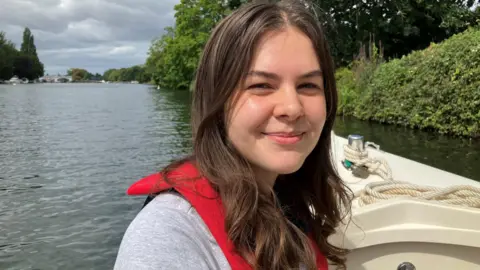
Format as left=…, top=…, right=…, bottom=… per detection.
left=146, top=0, right=229, bottom=90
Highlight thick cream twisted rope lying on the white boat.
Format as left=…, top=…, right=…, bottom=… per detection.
left=344, top=144, right=480, bottom=208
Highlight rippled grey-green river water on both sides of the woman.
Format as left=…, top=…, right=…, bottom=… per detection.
left=0, top=84, right=480, bottom=270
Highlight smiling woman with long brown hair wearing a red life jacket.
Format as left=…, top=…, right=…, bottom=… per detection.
left=115, top=1, right=349, bottom=270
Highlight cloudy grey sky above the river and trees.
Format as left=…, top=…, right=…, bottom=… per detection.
left=0, top=0, right=180, bottom=74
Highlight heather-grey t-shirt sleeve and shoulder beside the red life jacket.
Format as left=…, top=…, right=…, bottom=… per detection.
left=114, top=192, right=231, bottom=270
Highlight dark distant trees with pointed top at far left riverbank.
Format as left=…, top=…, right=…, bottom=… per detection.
left=0, top=28, right=44, bottom=80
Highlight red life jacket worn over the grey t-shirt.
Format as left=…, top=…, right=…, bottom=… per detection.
left=127, top=162, right=328, bottom=270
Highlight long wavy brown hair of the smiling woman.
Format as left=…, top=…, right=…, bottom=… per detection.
left=164, top=1, right=350, bottom=269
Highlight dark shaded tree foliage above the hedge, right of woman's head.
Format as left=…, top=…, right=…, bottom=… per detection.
left=312, top=0, right=480, bottom=66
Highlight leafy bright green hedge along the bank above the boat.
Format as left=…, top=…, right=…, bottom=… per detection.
left=336, top=27, right=480, bottom=138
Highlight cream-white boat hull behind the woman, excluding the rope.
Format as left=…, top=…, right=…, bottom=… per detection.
left=330, top=136, right=480, bottom=270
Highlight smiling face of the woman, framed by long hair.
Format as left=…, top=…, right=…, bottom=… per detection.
left=227, top=27, right=326, bottom=185
